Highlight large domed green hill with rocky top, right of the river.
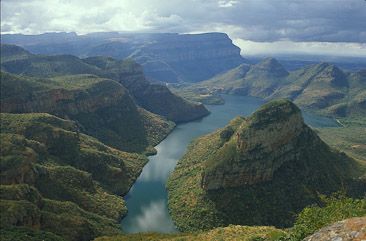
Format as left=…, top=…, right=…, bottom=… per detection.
left=167, top=100, right=363, bottom=231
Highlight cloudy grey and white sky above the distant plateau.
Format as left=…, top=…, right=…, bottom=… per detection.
left=1, top=0, right=366, bottom=57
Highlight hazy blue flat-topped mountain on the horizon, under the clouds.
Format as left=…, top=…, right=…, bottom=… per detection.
left=2, top=32, right=244, bottom=82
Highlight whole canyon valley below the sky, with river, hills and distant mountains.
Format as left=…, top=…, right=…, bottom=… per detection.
left=0, top=33, right=366, bottom=241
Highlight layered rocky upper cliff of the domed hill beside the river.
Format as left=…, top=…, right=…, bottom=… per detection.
left=202, top=100, right=322, bottom=190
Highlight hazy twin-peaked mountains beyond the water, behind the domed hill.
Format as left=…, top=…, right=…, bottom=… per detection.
left=186, top=58, right=366, bottom=116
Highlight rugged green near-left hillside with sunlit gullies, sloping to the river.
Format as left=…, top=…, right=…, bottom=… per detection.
left=0, top=113, right=147, bottom=240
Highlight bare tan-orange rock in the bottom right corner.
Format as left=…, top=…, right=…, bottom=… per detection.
left=304, top=217, right=366, bottom=241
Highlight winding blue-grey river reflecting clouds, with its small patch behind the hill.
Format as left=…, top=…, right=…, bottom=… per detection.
left=122, top=96, right=338, bottom=233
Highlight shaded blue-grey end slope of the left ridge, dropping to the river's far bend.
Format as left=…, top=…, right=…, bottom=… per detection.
left=84, top=57, right=209, bottom=122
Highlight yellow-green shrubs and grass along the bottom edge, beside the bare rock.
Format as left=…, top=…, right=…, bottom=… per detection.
left=95, top=193, right=366, bottom=241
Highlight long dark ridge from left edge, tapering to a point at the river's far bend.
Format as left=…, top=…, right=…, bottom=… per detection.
left=1, top=45, right=209, bottom=122
